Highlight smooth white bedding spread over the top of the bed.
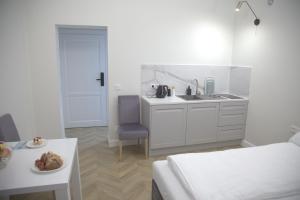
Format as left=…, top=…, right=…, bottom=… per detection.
left=167, top=143, right=300, bottom=200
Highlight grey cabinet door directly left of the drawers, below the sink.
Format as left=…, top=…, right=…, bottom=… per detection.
left=186, top=103, right=219, bottom=144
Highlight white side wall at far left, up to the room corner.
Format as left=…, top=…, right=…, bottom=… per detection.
left=0, top=1, right=35, bottom=139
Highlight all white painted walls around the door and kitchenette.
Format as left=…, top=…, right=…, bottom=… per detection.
left=0, top=0, right=300, bottom=145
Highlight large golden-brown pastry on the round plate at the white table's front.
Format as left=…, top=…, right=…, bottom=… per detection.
left=35, top=151, right=63, bottom=171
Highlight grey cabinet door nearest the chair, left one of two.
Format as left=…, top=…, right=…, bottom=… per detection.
left=150, top=105, right=187, bottom=149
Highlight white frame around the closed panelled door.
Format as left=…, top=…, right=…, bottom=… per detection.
left=55, top=24, right=109, bottom=130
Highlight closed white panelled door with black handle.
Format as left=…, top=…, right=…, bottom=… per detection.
left=58, top=28, right=107, bottom=128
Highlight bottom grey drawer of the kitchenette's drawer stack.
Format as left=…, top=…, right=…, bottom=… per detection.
left=217, top=125, right=245, bottom=141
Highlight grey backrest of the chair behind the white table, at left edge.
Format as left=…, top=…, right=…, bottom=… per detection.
left=0, top=114, right=20, bottom=142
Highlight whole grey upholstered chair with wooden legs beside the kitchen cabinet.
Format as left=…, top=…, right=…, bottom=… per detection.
left=118, top=95, right=148, bottom=160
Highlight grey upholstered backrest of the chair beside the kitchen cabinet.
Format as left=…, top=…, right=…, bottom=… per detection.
left=118, top=95, right=140, bottom=125
